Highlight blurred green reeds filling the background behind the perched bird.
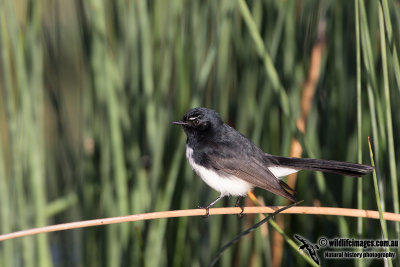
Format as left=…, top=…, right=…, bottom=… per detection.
left=0, top=0, right=400, bottom=266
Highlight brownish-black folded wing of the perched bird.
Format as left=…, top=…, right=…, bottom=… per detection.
left=203, top=142, right=296, bottom=202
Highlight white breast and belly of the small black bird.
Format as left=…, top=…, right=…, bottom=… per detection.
left=186, top=145, right=253, bottom=196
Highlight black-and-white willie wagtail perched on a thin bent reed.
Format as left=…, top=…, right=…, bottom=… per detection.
left=173, top=107, right=373, bottom=216
